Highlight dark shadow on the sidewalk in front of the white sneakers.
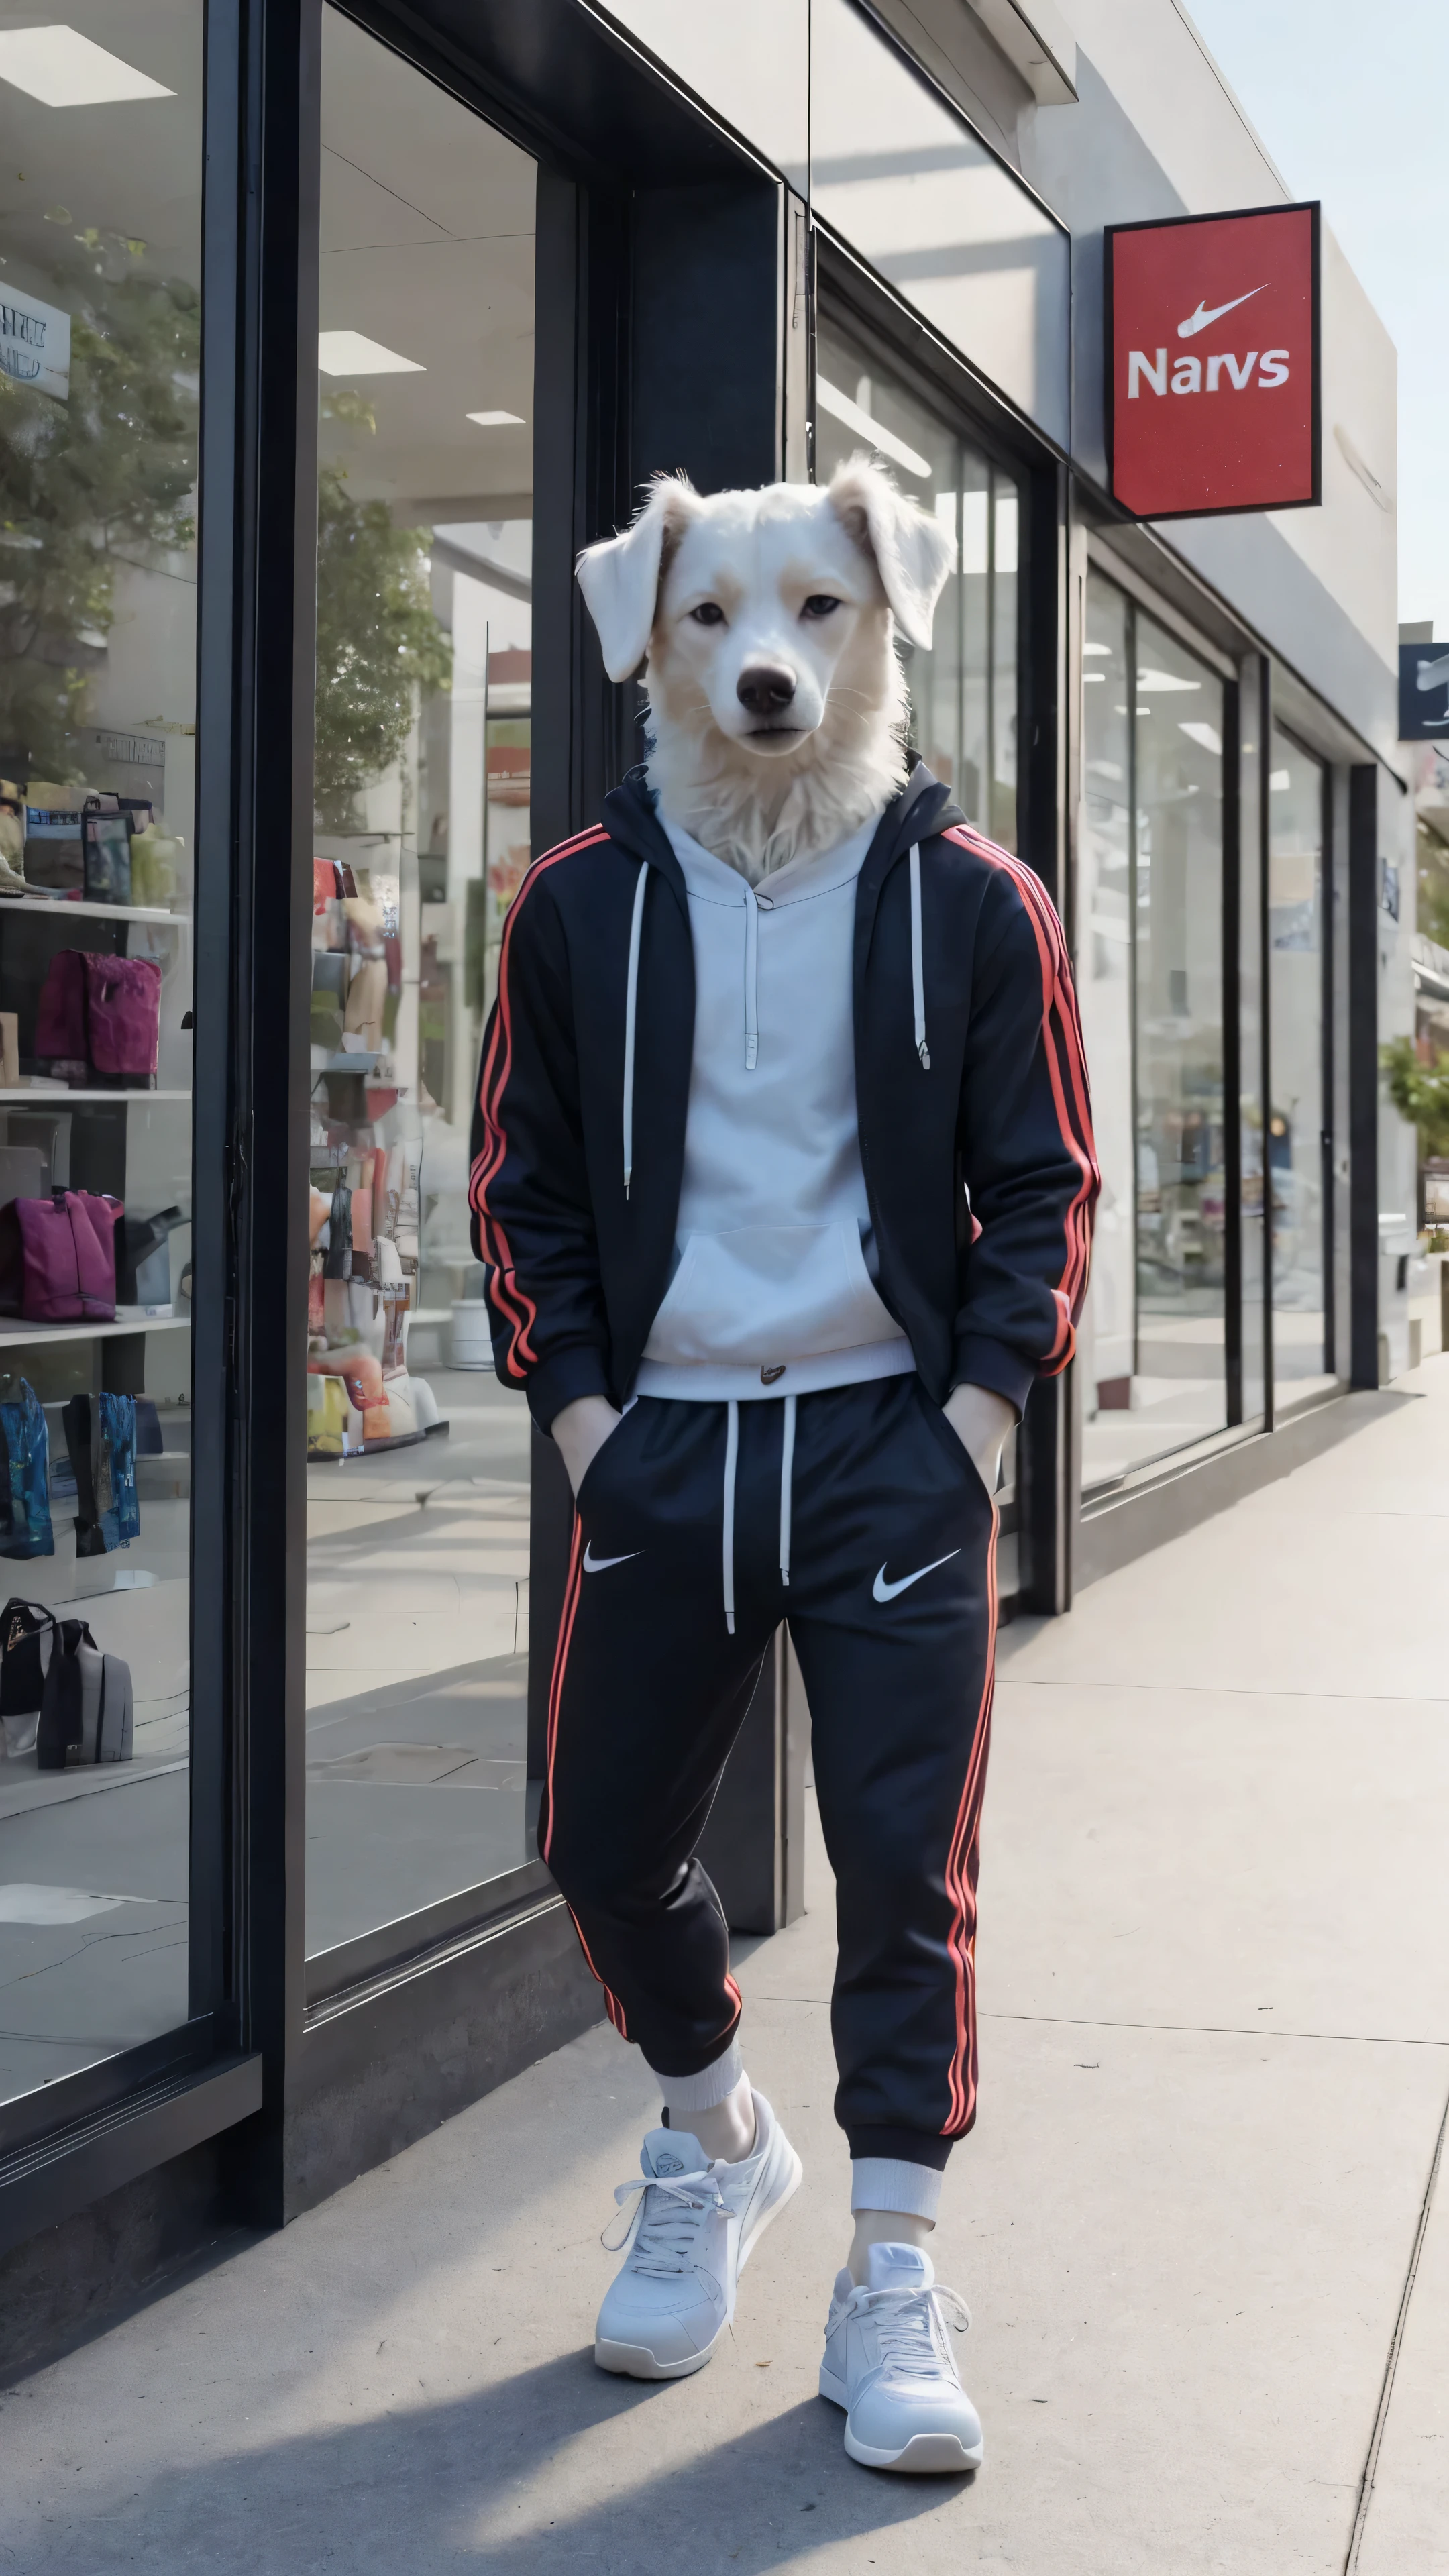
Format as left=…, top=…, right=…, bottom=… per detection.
left=62, top=2349, right=972, bottom=2576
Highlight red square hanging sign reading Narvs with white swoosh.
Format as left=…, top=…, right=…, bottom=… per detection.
left=1106, top=206, right=1320, bottom=518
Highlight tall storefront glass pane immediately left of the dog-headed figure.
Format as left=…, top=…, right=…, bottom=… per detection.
left=299, top=10, right=534, bottom=1966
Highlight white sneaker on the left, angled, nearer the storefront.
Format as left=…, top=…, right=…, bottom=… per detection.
left=593, top=2094, right=802, bottom=2380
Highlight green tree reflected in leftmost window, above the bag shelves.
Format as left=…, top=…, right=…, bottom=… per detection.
left=0, top=229, right=201, bottom=781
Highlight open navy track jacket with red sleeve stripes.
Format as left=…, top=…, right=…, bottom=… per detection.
left=470, top=765, right=1098, bottom=1432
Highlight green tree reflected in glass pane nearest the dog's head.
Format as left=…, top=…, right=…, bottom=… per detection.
left=315, top=389, right=453, bottom=824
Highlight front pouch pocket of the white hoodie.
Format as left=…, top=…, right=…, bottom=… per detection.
left=645, top=1224, right=900, bottom=1368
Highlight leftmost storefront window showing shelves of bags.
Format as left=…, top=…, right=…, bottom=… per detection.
left=0, top=0, right=201, bottom=2100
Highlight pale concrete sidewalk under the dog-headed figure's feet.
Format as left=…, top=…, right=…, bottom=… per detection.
left=0, top=1360, right=1449, bottom=2576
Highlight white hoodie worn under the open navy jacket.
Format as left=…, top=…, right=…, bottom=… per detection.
left=634, top=816, right=915, bottom=1401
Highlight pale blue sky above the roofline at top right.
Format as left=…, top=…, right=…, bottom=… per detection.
left=1186, top=0, right=1449, bottom=636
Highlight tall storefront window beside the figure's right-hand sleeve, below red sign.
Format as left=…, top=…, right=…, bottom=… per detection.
left=1078, top=574, right=1227, bottom=1491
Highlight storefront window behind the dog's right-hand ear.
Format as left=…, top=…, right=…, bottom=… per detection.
left=815, top=322, right=1018, bottom=850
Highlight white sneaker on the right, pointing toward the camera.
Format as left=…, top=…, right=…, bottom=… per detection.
left=820, top=2246, right=982, bottom=2473
